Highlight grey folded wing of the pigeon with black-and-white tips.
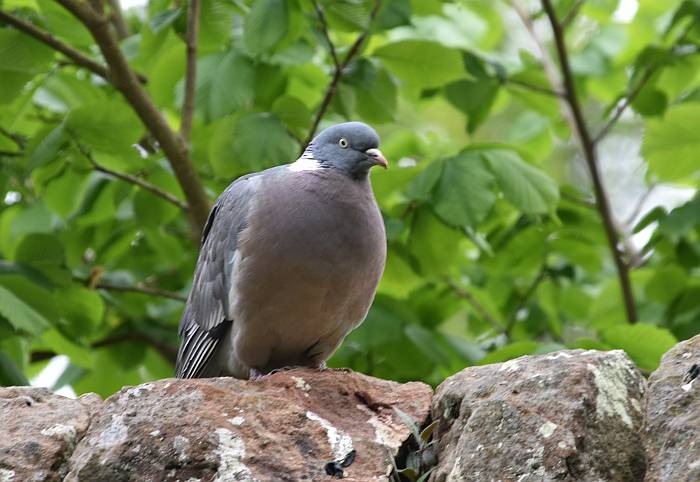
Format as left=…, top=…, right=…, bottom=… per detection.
left=175, top=174, right=259, bottom=378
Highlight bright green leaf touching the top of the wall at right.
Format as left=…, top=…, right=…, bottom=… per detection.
left=602, top=323, right=678, bottom=370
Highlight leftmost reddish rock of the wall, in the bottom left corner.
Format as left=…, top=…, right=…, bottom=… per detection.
left=0, top=387, right=102, bottom=482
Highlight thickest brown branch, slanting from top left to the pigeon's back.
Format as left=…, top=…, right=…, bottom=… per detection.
left=56, top=0, right=209, bottom=237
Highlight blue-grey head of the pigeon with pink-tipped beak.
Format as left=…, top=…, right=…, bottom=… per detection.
left=308, top=122, right=388, bottom=179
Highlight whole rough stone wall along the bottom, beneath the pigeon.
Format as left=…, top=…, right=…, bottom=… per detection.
left=0, top=336, right=700, bottom=482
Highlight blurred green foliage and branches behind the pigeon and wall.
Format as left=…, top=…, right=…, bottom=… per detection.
left=0, top=0, right=700, bottom=396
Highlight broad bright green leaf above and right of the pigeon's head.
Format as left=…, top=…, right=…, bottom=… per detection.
left=373, top=40, right=467, bottom=88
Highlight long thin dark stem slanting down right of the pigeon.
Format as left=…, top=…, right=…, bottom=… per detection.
left=542, top=0, right=637, bottom=323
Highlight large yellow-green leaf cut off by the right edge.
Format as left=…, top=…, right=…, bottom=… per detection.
left=642, top=103, right=700, bottom=181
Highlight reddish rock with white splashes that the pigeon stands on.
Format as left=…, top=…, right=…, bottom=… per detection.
left=66, top=369, right=432, bottom=482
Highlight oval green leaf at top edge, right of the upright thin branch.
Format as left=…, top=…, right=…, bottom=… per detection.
left=243, top=0, right=289, bottom=55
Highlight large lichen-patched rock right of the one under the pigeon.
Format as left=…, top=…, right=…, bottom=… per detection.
left=431, top=350, right=648, bottom=482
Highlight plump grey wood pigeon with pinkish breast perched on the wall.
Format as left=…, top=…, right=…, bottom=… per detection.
left=176, top=122, right=387, bottom=379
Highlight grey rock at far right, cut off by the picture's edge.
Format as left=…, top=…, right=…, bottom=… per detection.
left=644, top=335, right=700, bottom=482
